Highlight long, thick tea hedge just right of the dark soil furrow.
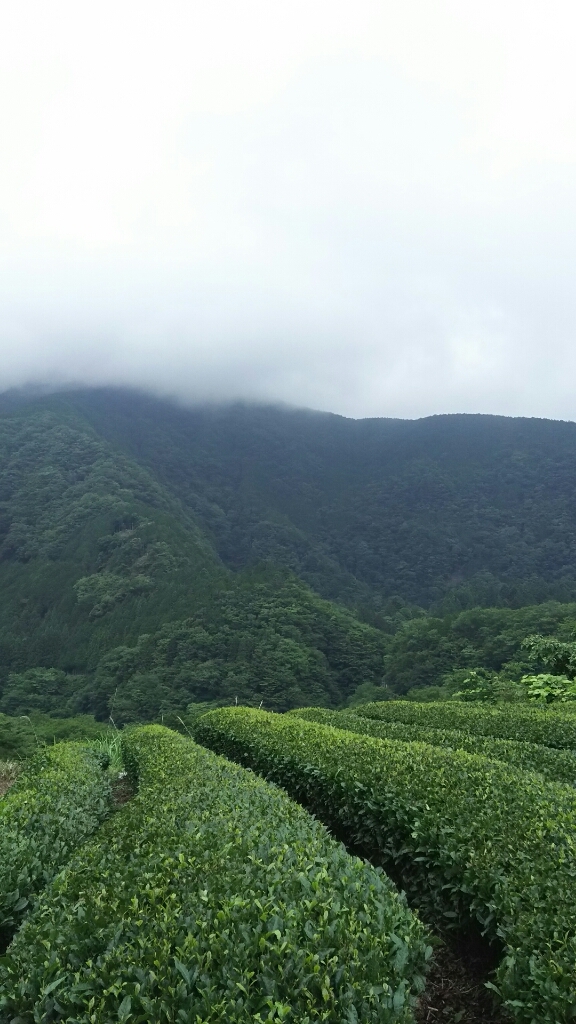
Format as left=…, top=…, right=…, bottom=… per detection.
left=197, top=708, right=576, bottom=1024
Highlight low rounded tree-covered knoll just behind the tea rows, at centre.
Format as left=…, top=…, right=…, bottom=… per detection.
left=92, top=569, right=384, bottom=722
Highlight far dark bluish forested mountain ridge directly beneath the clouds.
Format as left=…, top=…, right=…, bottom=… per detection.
left=59, top=390, right=576, bottom=611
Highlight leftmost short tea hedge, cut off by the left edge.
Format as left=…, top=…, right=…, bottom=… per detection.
left=0, top=743, right=110, bottom=939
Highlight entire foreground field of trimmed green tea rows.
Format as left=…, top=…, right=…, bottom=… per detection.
left=0, top=700, right=576, bottom=1024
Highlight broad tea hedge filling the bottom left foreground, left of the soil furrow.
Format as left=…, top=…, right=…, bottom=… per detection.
left=0, top=726, right=430, bottom=1024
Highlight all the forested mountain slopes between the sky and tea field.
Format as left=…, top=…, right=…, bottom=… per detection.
left=0, top=390, right=576, bottom=723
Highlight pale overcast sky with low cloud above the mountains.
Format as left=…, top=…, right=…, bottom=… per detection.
left=0, top=0, right=576, bottom=419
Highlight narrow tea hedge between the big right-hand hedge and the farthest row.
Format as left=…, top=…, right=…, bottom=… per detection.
left=290, top=708, right=576, bottom=785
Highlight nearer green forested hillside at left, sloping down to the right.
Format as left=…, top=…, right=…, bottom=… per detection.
left=0, top=400, right=383, bottom=721
